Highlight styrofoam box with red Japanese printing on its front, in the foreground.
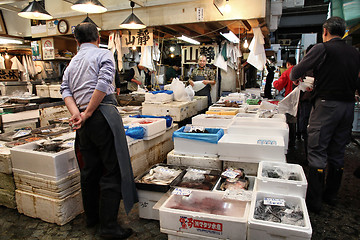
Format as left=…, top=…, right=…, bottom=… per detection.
left=160, top=190, right=249, bottom=240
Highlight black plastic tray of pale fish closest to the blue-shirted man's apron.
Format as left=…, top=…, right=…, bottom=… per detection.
left=135, top=163, right=186, bottom=193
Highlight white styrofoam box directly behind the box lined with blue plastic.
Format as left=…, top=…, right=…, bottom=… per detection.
left=191, top=114, right=234, bottom=128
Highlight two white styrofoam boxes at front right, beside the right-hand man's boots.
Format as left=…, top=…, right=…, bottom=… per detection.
left=248, top=162, right=312, bottom=240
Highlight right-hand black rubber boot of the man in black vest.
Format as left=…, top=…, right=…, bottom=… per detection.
left=324, top=164, right=344, bottom=206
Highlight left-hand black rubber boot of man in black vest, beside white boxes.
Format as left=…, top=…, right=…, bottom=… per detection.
left=306, top=167, right=325, bottom=213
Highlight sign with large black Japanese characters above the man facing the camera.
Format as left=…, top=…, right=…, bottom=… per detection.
left=181, top=45, right=217, bottom=64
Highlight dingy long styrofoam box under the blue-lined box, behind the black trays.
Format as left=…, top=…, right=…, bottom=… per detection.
left=167, top=150, right=222, bottom=170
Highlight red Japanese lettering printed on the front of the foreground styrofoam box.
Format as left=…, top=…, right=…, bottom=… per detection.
left=179, top=216, right=223, bottom=235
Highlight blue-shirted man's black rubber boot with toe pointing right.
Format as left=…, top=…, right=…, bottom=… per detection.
left=100, top=194, right=133, bottom=239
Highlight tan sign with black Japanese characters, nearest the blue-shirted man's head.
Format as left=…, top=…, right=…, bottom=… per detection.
left=121, top=28, right=154, bottom=47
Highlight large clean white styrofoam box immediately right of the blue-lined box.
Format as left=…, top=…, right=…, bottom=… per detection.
left=217, top=134, right=286, bottom=162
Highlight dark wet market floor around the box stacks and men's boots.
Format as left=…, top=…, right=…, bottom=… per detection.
left=0, top=135, right=360, bottom=240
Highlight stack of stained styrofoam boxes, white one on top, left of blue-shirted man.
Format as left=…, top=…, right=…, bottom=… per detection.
left=11, top=133, right=83, bottom=225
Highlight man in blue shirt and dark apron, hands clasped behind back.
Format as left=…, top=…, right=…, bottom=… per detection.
left=61, top=23, right=138, bottom=239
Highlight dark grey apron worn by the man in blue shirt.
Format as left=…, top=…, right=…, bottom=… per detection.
left=75, top=94, right=139, bottom=214
